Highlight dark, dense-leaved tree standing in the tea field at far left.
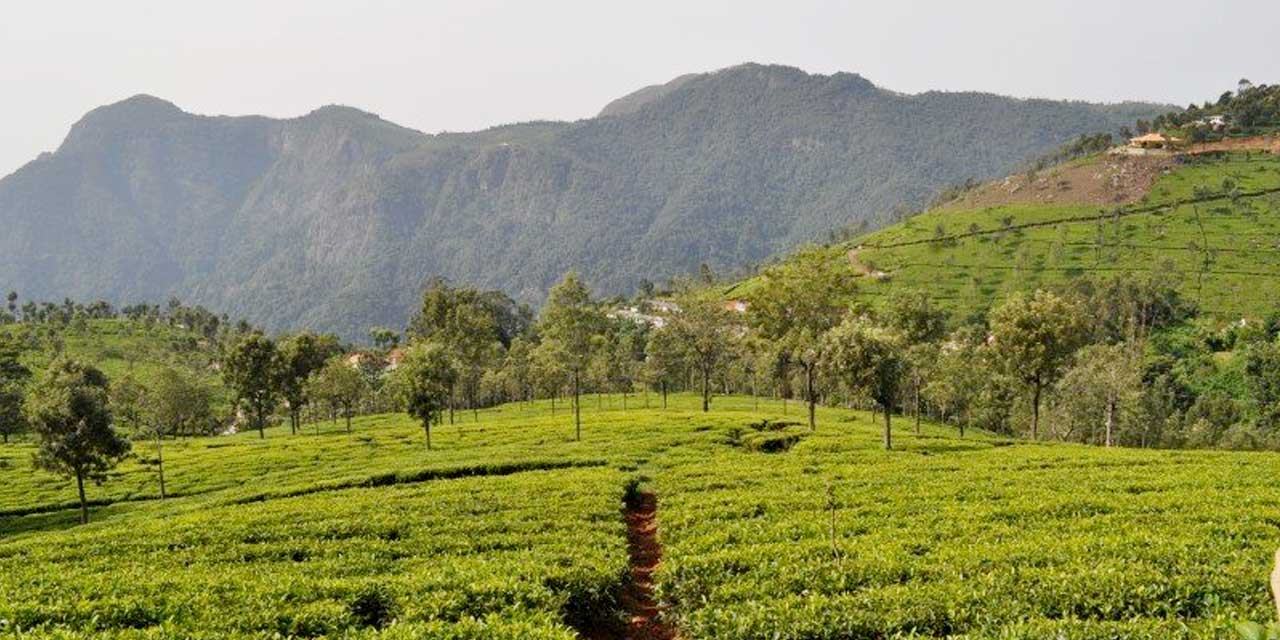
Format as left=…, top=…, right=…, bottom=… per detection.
left=26, top=358, right=129, bottom=525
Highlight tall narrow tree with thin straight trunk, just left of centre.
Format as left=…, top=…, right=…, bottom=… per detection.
left=539, top=271, right=604, bottom=440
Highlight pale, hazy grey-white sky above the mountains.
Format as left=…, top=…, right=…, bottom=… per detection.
left=0, top=0, right=1280, bottom=175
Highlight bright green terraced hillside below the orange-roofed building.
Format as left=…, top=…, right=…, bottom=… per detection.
left=728, top=150, right=1280, bottom=319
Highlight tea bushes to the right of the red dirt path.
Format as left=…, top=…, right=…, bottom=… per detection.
left=655, top=424, right=1280, bottom=640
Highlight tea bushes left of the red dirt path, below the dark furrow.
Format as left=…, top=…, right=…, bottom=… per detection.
left=0, top=467, right=627, bottom=639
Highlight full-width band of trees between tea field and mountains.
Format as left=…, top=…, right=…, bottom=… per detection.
left=0, top=251, right=1280, bottom=520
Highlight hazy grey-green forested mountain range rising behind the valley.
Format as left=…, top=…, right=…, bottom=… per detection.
left=0, top=65, right=1161, bottom=337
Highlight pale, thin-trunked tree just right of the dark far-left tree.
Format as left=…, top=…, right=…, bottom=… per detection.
left=137, top=369, right=214, bottom=499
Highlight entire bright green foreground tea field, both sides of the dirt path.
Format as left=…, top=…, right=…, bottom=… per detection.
left=0, top=396, right=1280, bottom=639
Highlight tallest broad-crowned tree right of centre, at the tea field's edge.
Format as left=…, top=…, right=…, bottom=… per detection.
left=749, top=250, right=855, bottom=430
